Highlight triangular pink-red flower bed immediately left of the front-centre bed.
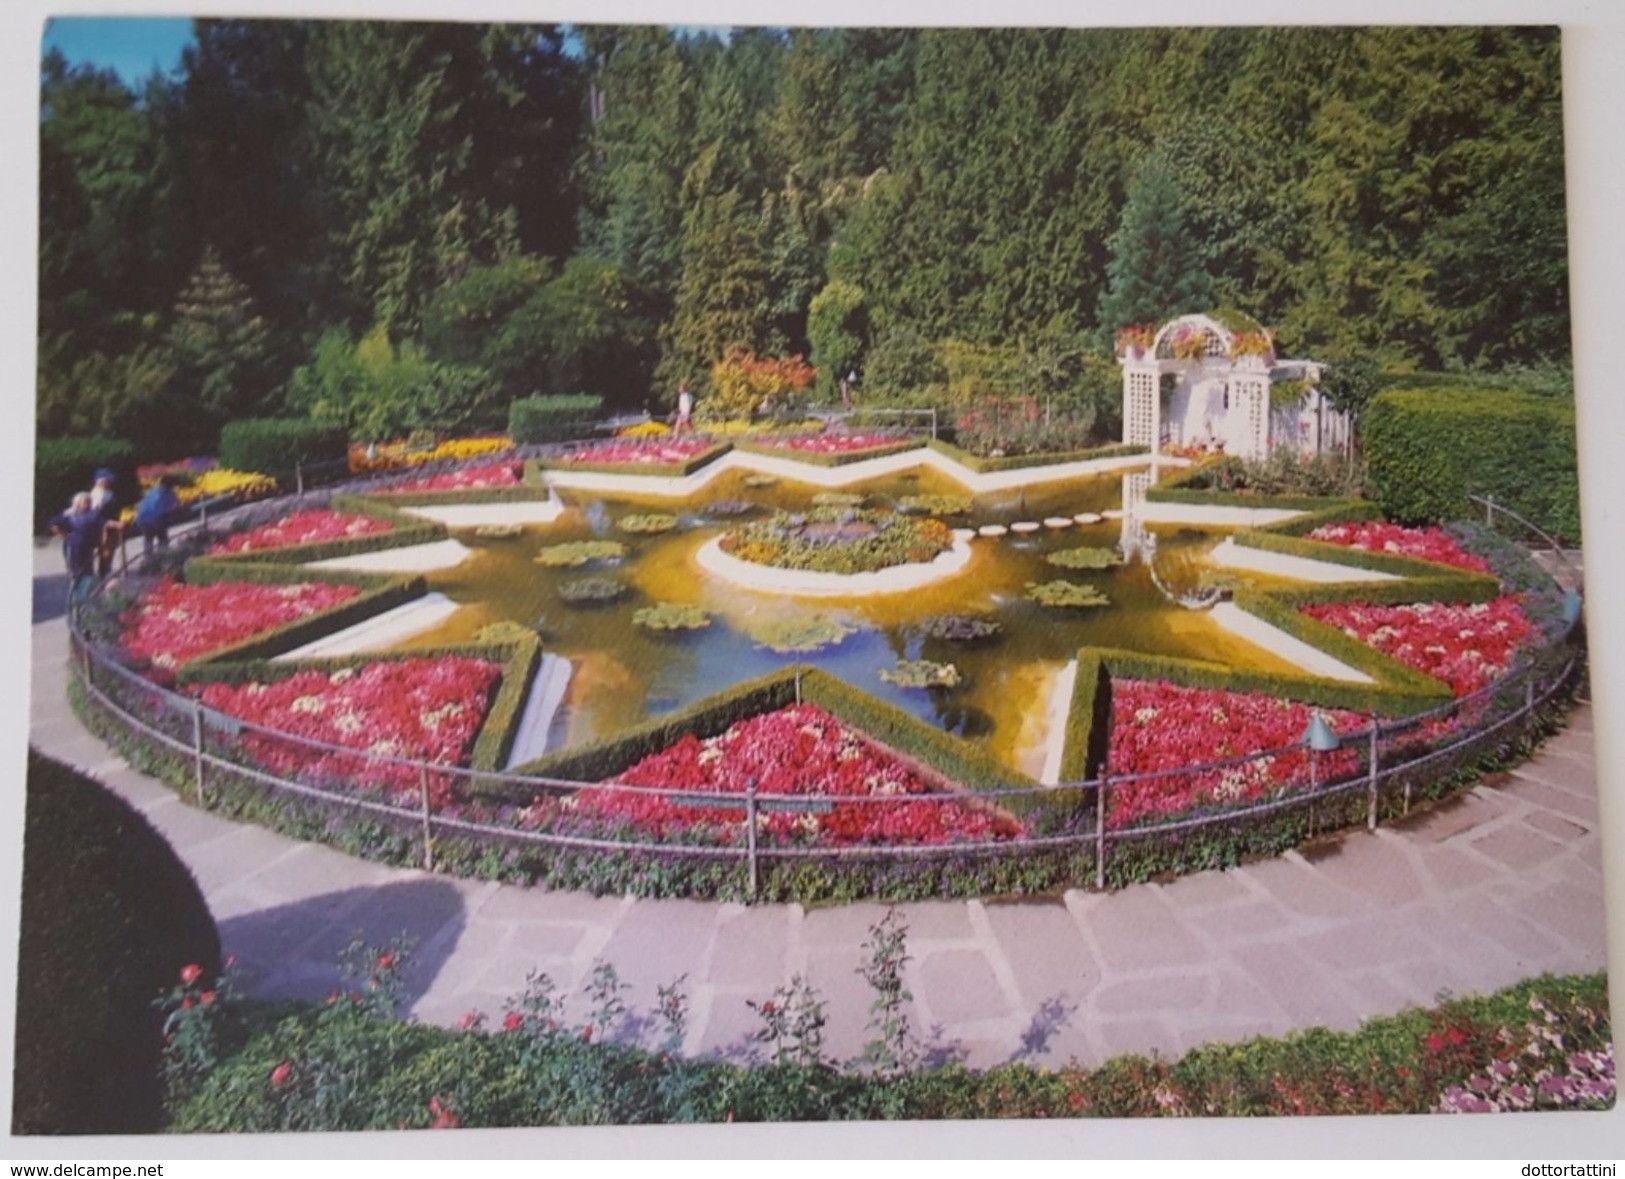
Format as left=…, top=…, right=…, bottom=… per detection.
left=193, top=656, right=502, bottom=810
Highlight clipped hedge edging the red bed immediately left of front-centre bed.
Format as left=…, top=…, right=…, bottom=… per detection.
left=177, top=635, right=541, bottom=771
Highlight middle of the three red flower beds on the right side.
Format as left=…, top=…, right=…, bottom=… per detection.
left=1302, top=596, right=1536, bottom=697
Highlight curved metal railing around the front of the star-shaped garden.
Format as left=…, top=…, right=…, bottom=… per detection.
left=68, top=457, right=1583, bottom=898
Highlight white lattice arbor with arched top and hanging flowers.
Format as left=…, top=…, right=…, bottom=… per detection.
left=1118, top=313, right=1349, bottom=458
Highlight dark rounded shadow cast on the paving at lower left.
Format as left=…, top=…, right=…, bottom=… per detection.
left=219, top=880, right=465, bottom=1010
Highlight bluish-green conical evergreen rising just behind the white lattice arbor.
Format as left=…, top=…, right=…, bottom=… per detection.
left=1099, top=154, right=1212, bottom=333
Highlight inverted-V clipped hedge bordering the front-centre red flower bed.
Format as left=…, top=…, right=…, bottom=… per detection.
left=492, top=675, right=1035, bottom=802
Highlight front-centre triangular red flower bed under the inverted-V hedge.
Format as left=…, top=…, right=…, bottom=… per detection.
left=567, top=703, right=1021, bottom=844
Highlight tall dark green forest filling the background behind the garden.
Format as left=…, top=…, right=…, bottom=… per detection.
left=37, top=19, right=1570, bottom=458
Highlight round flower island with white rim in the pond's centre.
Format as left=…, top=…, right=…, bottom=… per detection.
left=696, top=507, right=970, bottom=596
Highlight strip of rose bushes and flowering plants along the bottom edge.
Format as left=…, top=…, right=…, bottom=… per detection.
left=158, top=916, right=1614, bottom=1132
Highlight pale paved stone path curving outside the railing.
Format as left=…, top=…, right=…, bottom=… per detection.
left=31, top=547, right=1606, bottom=1067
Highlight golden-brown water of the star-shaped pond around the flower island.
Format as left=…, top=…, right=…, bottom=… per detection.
left=399, top=469, right=1292, bottom=775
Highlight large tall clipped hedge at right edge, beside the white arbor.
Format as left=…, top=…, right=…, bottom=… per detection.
left=1360, top=385, right=1580, bottom=542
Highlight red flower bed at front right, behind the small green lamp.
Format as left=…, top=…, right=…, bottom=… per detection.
left=1107, top=679, right=1367, bottom=828
